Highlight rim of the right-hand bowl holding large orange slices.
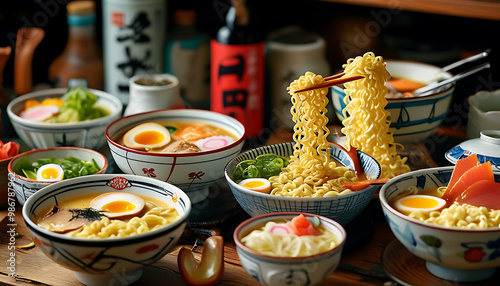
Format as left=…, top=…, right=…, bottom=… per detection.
left=379, top=166, right=500, bottom=233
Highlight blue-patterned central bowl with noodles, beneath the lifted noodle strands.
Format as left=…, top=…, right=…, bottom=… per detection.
left=225, top=142, right=381, bottom=225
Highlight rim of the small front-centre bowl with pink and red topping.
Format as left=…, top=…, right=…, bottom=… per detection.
left=233, top=212, right=347, bottom=262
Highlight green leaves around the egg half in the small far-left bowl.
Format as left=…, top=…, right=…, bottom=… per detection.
left=13, top=157, right=101, bottom=180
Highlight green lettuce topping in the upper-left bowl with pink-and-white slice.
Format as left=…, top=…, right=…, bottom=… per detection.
left=48, top=86, right=109, bottom=123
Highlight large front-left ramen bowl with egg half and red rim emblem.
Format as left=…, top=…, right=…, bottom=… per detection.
left=22, top=174, right=191, bottom=285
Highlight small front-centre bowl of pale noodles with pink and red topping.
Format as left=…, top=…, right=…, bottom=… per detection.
left=233, top=212, right=346, bottom=286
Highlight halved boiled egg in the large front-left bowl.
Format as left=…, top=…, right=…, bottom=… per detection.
left=90, top=192, right=145, bottom=218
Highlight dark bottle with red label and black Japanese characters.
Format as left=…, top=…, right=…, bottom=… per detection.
left=210, top=0, right=265, bottom=137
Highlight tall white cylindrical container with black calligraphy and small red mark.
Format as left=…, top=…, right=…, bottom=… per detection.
left=102, top=0, right=167, bottom=105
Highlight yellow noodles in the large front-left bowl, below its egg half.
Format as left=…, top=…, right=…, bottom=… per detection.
left=67, top=206, right=179, bottom=239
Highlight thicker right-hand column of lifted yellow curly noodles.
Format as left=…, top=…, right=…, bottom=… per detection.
left=341, top=52, right=410, bottom=178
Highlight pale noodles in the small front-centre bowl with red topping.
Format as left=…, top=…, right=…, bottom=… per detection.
left=241, top=221, right=338, bottom=257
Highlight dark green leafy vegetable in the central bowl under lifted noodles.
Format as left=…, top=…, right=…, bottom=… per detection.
left=233, top=154, right=290, bottom=183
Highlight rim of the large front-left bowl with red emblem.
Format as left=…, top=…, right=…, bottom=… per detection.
left=22, top=174, right=192, bottom=247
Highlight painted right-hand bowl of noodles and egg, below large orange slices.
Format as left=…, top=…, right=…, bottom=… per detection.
left=379, top=166, right=500, bottom=284
